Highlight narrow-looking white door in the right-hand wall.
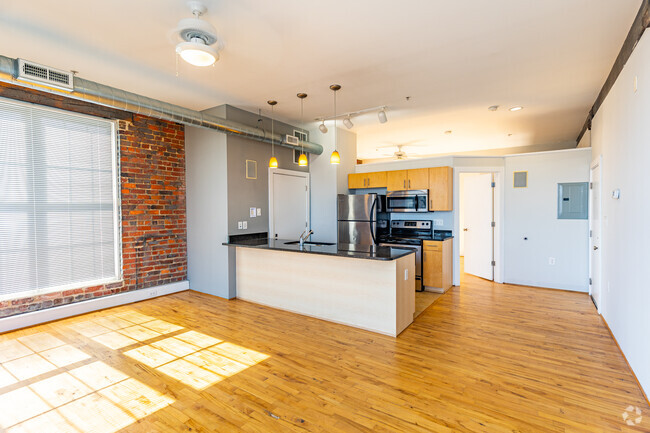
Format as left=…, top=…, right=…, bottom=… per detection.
left=589, top=163, right=601, bottom=312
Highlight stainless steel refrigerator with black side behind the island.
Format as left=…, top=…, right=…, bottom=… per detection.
left=337, top=194, right=381, bottom=250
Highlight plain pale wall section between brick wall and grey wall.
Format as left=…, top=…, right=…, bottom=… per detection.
left=185, top=126, right=234, bottom=298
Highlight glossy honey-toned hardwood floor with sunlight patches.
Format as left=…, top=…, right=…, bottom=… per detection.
left=0, top=275, right=650, bottom=433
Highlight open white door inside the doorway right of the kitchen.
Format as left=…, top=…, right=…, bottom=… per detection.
left=462, top=173, right=494, bottom=280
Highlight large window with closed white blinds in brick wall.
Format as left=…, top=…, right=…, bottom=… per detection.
left=0, top=99, right=121, bottom=300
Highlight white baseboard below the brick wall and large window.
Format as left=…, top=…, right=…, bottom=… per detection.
left=0, top=281, right=190, bottom=334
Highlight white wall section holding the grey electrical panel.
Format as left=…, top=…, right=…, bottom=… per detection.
left=504, top=149, right=591, bottom=292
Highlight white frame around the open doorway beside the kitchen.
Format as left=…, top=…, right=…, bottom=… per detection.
left=453, top=167, right=505, bottom=286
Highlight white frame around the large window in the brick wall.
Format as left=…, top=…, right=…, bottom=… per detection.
left=0, top=98, right=124, bottom=302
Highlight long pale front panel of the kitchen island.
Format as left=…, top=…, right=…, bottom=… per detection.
left=237, top=248, right=398, bottom=336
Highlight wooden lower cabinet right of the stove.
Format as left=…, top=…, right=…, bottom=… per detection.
left=422, top=238, right=453, bottom=293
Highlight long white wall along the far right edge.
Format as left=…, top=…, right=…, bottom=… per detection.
left=591, top=31, right=650, bottom=395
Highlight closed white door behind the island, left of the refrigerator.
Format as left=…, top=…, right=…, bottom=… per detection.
left=269, top=170, right=309, bottom=240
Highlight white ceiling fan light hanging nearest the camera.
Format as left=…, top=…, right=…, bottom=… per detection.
left=175, top=1, right=219, bottom=66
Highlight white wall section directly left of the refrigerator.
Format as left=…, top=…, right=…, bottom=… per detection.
left=309, top=128, right=357, bottom=242
